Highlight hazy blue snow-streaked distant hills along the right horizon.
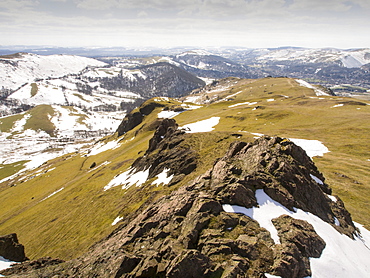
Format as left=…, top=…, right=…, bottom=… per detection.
left=98, top=47, right=370, bottom=99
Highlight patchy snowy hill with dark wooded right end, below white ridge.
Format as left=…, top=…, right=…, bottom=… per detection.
left=3, top=63, right=204, bottom=111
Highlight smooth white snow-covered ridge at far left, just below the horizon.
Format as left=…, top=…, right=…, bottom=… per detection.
left=0, top=53, right=107, bottom=90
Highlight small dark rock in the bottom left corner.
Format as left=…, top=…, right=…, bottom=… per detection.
left=0, top=234, right=27, bottom=262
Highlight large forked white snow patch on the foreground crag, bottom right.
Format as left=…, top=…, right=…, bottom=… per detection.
left=223, top=189, right=370, bottom=278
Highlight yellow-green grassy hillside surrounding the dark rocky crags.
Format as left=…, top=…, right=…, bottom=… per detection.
left=0, top=78, right=370, bottom=259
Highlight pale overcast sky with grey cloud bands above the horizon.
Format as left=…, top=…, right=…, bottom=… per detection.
left=0, top=0, right=370, bottom=48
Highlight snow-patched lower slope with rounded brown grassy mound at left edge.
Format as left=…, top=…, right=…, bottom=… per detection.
left=0, top=105, right=125, bottom=175
